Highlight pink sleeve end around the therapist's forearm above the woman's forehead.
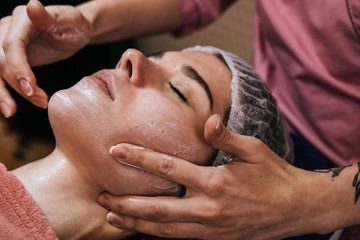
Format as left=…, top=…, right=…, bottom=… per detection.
left=175, top=0, right=236, bottom=36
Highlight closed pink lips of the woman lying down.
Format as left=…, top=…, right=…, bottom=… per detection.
left=87, top=70, right=115, bottom=101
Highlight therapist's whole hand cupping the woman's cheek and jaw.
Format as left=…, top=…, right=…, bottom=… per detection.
left=99, top=115, right=307, bottom=240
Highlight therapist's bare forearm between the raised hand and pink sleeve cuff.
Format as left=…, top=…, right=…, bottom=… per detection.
left=77, top=0, right=181, bottom=43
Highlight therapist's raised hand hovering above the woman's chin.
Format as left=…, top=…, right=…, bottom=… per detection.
left=0, top=0, right=92, bottom=117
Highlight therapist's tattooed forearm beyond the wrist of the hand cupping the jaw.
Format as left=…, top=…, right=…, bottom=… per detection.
left=302, top=163, right=360, bottom=233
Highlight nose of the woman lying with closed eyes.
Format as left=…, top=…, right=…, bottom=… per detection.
left=116, top=49, right=156, bottom=87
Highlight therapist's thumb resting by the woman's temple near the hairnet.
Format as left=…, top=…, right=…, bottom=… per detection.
left=204, top=114, right=267, bottom=162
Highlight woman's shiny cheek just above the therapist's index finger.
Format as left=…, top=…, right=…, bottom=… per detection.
left=115, top=94, right=205, bottom=163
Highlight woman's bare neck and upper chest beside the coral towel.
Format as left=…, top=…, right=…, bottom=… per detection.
left=13, top=149, right=130, bottom=239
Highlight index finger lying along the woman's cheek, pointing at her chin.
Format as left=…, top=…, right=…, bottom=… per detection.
left=110, top=144, right=208, bottom=189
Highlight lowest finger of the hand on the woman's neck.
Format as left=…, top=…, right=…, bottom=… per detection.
left=106, top=212, right=208, bottom=239
